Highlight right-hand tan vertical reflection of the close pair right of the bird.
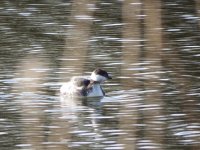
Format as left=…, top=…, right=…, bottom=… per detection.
left=143, top=0, right=165, bottom=149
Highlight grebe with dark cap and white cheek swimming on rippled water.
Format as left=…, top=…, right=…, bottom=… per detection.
left=60, top=69, right=112, bottom=97
